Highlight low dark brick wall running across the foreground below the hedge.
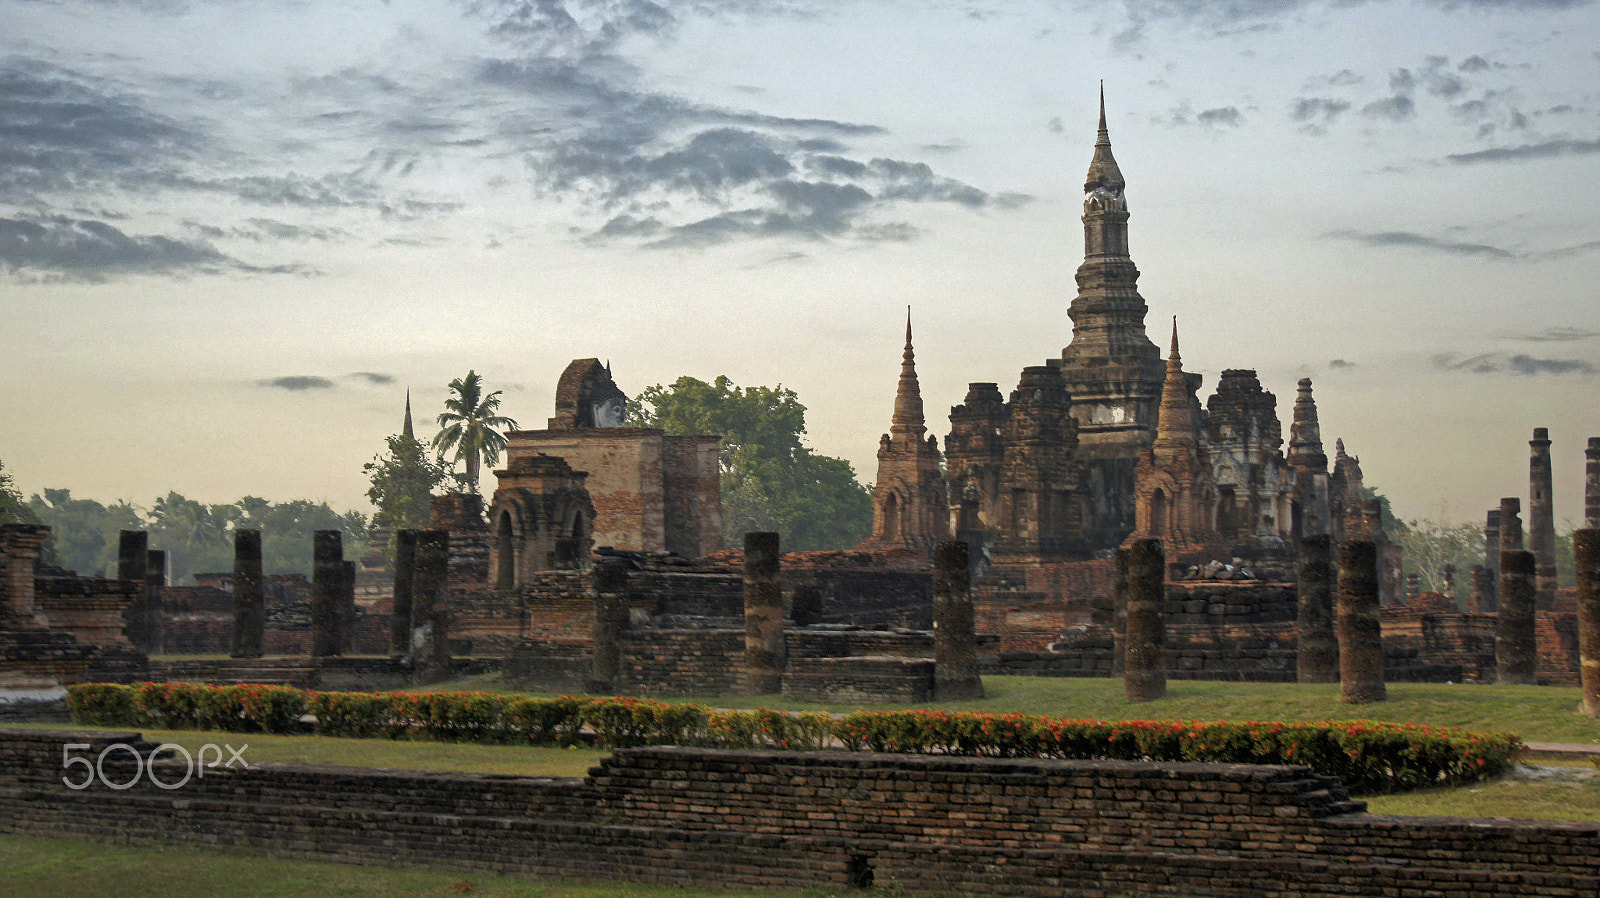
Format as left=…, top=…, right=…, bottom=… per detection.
left=0, top=732, right=1600, bottom=898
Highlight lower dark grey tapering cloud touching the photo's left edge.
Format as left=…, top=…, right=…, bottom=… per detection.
left=0, top=218, right=301, bottom=282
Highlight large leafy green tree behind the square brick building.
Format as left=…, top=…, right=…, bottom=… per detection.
left=626, top=376, right=872, bottom=551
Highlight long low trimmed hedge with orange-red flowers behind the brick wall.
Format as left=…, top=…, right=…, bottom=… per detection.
left=67, top=684, right=1522, bottom=794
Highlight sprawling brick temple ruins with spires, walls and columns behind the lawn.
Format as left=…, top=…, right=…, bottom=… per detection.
left=5, top=94, right=1600, bottom=701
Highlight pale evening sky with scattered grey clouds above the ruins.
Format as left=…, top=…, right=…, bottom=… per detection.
left=0, top=0, right=1600, bottom=528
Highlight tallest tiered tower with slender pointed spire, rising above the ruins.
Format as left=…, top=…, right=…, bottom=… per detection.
left=1050, top=88, right=1166, bottom=546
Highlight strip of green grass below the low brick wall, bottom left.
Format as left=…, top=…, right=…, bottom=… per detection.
left=0, top=834, right=827, bottom=898
